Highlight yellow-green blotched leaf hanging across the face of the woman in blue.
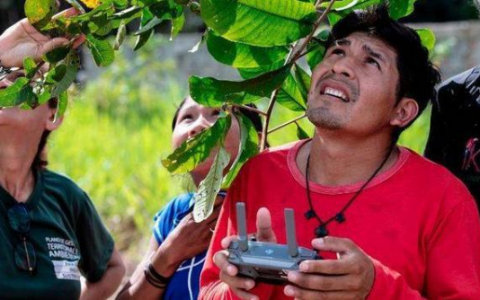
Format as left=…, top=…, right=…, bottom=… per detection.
left=162, top=116, right=231, bottom=174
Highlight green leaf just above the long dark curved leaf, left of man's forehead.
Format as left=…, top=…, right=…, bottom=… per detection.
left=207, top=30, right=289, bottom=68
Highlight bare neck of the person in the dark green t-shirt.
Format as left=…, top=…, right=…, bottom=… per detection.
left=0, top=137, right=36, bottom=202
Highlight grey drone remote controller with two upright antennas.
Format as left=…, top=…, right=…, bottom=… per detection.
left=228, top=202, right=321, bottom=284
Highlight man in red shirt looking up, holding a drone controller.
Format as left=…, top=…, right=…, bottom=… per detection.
left=200, top=7, right=480, bottom=300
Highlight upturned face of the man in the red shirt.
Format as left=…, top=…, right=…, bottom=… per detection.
left=307, top=33, right=399, bottom=135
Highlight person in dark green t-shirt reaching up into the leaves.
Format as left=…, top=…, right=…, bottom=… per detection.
left=0, top=11, right=125, bottom=300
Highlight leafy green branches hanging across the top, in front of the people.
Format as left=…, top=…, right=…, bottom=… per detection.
left=0, top=0, right=435, bottom=221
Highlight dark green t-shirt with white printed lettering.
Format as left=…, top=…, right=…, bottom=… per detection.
left=0, top=171, right=114, bottom=299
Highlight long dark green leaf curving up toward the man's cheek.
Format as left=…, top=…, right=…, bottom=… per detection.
left=189, top=64, right=292, bottom=107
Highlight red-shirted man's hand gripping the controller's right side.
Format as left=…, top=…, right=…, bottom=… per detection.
left=284, top=237, right=375, bottom=299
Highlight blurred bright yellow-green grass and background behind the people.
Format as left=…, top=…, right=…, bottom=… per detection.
left=48, top=39, right=429, bottom=261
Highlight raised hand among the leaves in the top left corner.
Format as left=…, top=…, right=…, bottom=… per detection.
left=0, top=8, right=85, bottom=67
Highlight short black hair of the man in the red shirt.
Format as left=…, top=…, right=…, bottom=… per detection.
left=327, top=5, right=440, bottom=139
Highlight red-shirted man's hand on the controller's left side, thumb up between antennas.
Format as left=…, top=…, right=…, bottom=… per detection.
left=213, top=208, right=277, bottom=300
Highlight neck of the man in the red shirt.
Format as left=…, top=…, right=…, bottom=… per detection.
left=297, top=133, right=398, bottom=186
